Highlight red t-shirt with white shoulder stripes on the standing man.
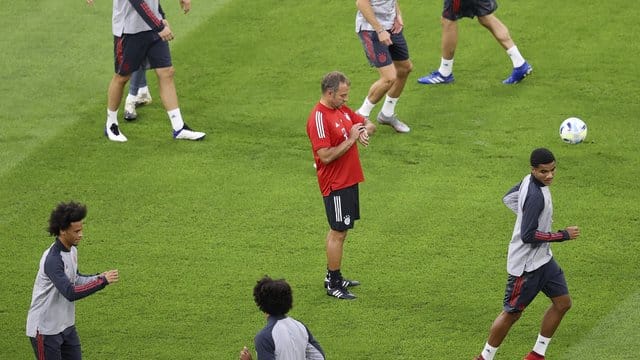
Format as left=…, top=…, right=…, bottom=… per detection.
left=307, top=103, right=365, bottom=196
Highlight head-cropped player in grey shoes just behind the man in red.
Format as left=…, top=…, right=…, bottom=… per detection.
left=356, top=0, right=413, bottom=133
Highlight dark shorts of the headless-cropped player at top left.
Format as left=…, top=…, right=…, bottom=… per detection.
left=113, top=30, right=171, bottom=76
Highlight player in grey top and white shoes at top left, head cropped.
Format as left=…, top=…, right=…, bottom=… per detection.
left=105, top=0, right=206, bottom=142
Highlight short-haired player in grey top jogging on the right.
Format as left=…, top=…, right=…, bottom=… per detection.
left=476, top=148, right=580, bottom=360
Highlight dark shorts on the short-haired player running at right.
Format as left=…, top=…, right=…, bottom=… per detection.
left=504, top=258, right=569, bottom=313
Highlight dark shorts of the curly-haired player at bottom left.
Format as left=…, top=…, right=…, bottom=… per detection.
left=29, top=325, right=82, bottom=360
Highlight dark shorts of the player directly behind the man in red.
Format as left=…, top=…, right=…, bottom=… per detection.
left=358, top=30, right=409, bottom=68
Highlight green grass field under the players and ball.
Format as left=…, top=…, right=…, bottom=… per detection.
left=0, top=0, right=640, bottom=360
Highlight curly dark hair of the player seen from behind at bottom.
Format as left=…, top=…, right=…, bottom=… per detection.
left=253, top=275, right=293, bottom=316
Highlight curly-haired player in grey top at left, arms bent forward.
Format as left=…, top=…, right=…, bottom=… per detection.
left=27, top=202, right=118, bottom=360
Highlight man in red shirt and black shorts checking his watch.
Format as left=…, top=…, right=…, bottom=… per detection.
left=307, top=71, right=375, bottom=300
